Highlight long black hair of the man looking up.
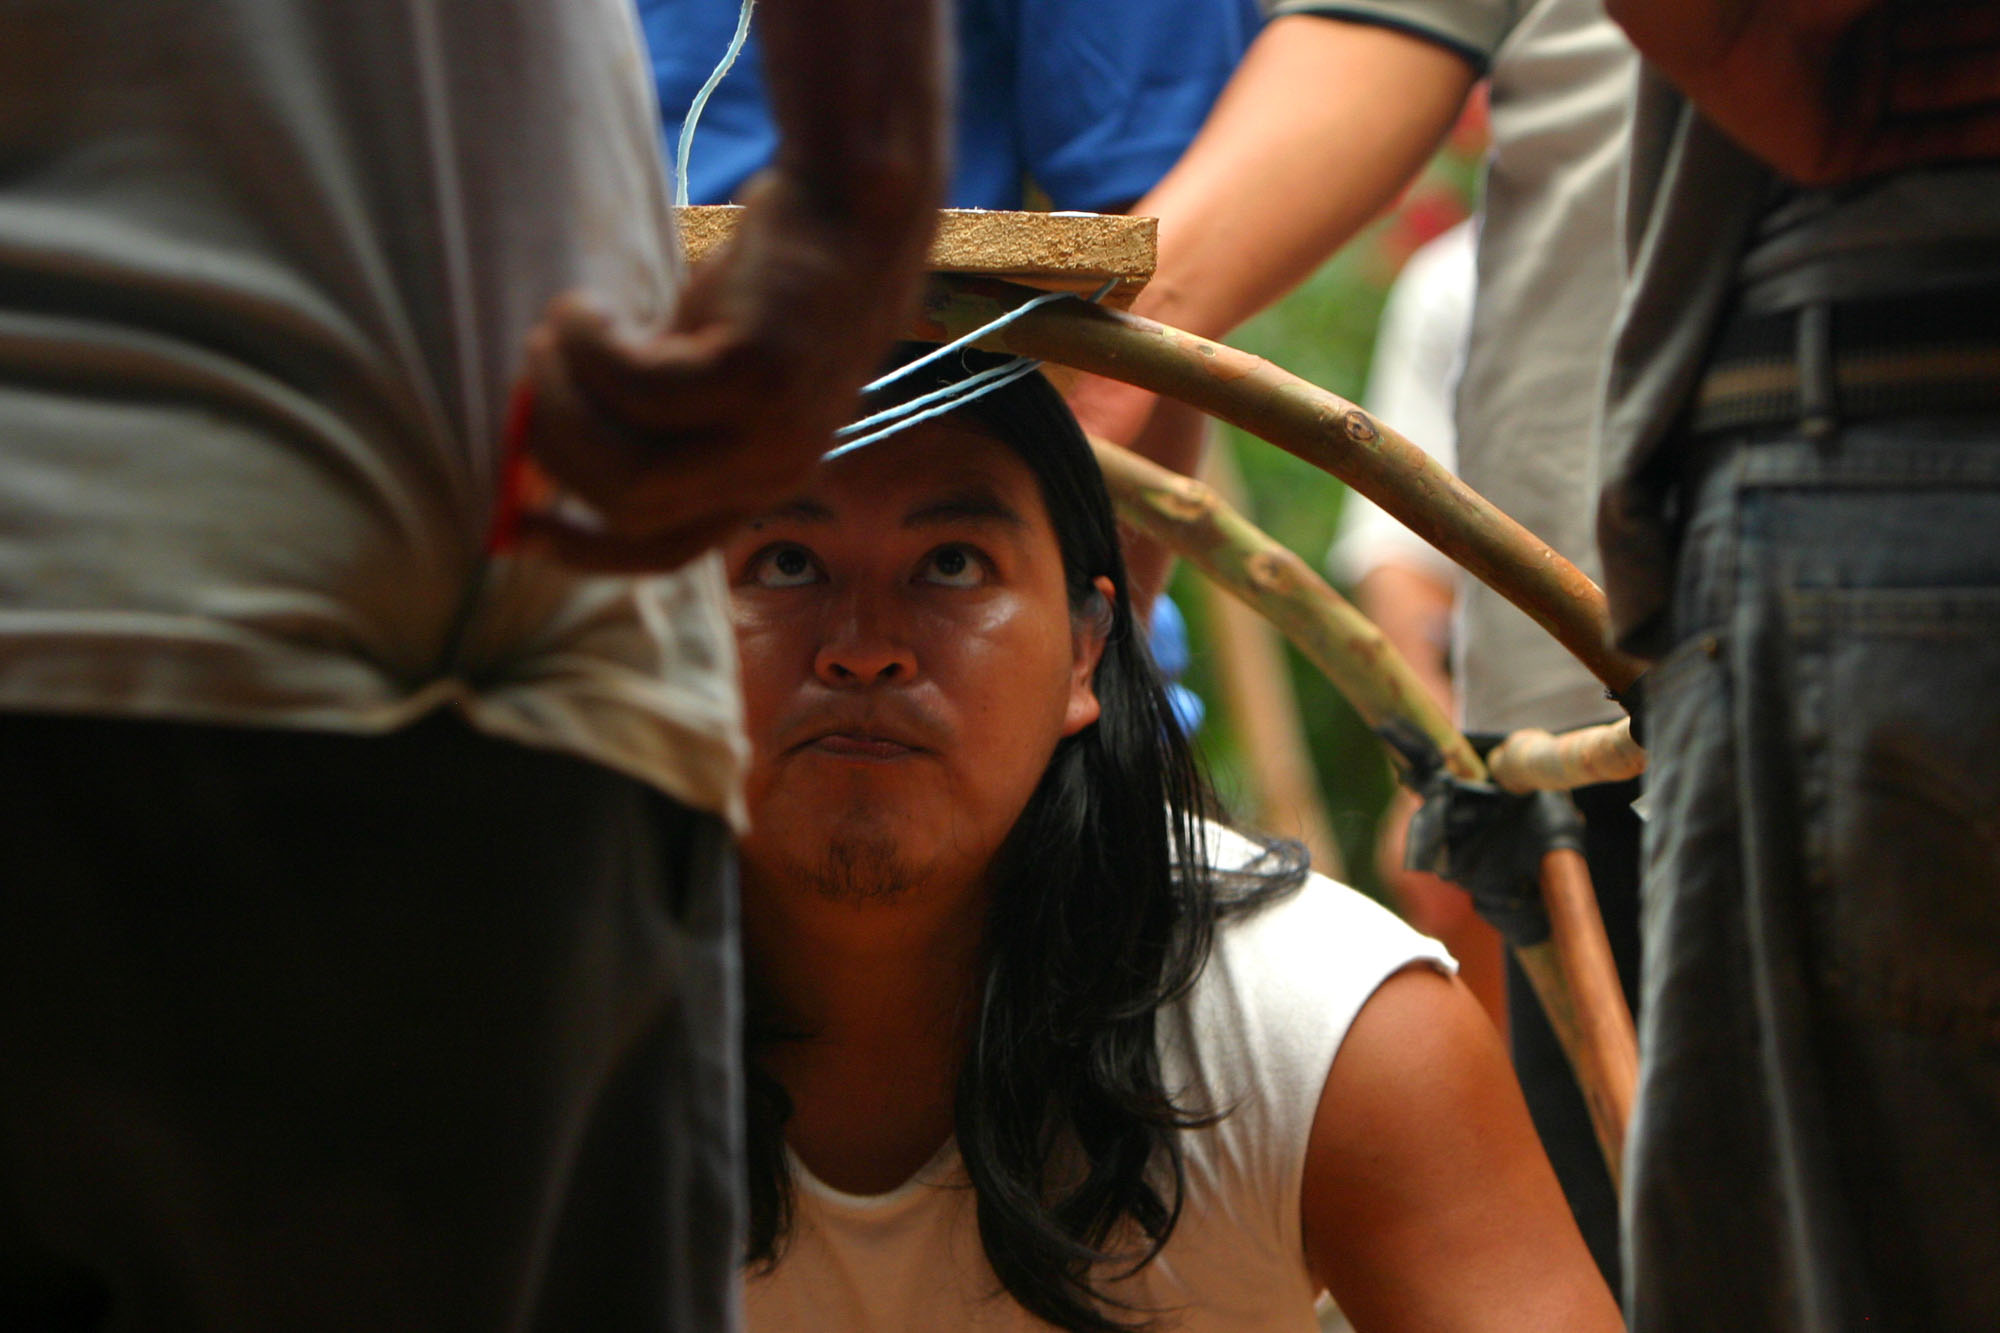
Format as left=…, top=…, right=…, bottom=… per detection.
left=748, top=344, right=1306, bottom=1333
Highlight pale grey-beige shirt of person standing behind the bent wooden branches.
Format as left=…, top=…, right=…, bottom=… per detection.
left=1276, top=0, right=1638, bottom=733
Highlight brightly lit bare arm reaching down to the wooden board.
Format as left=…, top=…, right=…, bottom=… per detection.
left=1134, top=16, right=1474, bottom=338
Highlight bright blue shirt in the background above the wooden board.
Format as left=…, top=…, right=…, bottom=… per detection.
left=638, top=0, right=1262, bottom=212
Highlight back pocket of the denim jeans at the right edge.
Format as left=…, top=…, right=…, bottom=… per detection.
left=1792, top=588, right=2000, bottom=1047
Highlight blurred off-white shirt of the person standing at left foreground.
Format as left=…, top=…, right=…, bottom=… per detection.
left=0, top=0, right=744, bottom=813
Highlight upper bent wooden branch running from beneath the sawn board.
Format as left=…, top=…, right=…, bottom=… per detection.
left=922, top=278, right=1642, bottom=693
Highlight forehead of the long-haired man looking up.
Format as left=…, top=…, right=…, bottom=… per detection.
left=756, top=416, right=1054, bottom=542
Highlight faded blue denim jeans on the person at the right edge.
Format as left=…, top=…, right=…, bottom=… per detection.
left=1624, top=414, right=2000, bottom=1333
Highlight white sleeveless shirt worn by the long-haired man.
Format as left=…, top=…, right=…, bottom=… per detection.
left=746, top=835, right=1454, bottom=1333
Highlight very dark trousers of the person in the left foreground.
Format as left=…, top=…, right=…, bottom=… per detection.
left=0, top=715, right=742, bottom=1333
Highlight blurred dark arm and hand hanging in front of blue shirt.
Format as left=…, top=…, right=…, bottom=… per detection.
left=522, top=0, right=946, bottom=568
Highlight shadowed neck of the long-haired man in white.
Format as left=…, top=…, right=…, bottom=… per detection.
left=744, top=867, right=988, bottom=1193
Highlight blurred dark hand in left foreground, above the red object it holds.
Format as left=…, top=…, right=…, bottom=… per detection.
left=508, top=172, right=930, bottom=570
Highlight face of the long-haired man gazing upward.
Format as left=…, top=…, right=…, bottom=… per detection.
left=726, top=418, right=1108, bottom=899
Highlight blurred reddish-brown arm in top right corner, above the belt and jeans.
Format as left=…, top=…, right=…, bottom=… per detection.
left=1606, top=0, right=2000, bottom=186
